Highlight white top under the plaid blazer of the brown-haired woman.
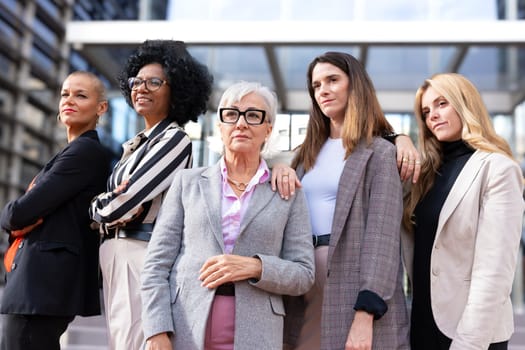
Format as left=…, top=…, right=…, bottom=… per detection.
left=301, top=138, right=345, bottom=235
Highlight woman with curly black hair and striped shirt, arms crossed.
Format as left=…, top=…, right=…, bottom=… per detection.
left=91, top=40, right=213, bottom=349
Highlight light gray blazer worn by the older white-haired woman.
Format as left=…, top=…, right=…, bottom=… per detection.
left=142, top=164, right=315, bottom=350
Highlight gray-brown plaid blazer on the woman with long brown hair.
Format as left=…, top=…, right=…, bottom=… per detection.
left=286, top=138, right=409, bottom=350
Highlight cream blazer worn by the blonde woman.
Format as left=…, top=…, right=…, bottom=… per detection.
left=402, top=151, right=524, bottom=350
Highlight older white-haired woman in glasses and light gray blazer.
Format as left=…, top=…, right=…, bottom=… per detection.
left=142, top=82, right=314, bottom=350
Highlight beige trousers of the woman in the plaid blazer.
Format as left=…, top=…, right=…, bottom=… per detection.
left=295, top=246, right=328, bottom=350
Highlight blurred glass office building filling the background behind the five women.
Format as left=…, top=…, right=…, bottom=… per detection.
left=0, top=0, right=525, bottom=266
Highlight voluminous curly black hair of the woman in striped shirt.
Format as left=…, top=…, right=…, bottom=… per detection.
left=118, top=40, right=213, bottom=126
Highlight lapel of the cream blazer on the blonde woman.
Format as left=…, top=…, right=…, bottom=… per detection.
left=436, top=151, right=486, bottom=239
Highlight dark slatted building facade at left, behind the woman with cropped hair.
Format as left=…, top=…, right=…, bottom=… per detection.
left=0, top=0, right=145, bottom=281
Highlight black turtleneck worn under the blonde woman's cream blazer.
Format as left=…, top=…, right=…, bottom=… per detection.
left=410, top=140, right=474, bottom=350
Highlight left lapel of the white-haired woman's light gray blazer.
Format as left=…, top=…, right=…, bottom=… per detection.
left=197, top=164, right=224, bottom=251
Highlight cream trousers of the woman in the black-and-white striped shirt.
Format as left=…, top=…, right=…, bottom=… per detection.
left=100, top=238, right=148, bottom=350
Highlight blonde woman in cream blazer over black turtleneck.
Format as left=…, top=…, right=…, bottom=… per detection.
left=402, top=74, right=524, bottom=350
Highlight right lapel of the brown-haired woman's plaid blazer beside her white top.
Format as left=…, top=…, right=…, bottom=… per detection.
left=328, top=143, right=372, bottom=261
